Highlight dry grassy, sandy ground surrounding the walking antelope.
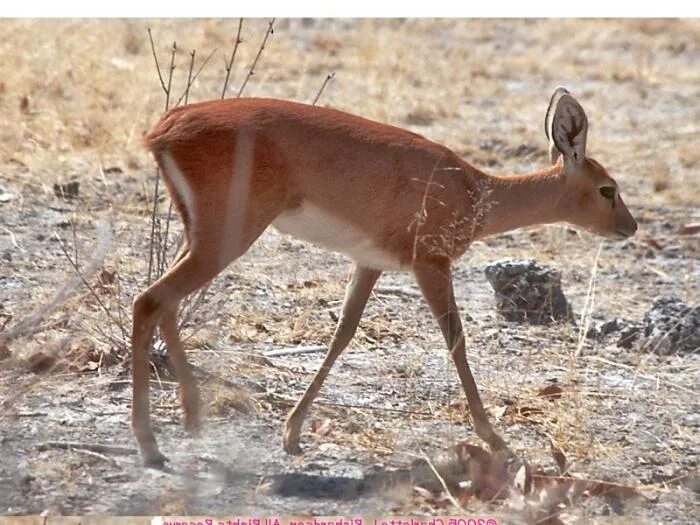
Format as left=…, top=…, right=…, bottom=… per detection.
left=0, top=19, right=700, bottom=523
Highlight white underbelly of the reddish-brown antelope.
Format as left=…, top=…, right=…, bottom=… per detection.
left=272, top=201, right=401, bottom=270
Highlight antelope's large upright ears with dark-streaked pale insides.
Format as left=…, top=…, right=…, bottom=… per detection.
left=544, top=87, right=588, bottom=164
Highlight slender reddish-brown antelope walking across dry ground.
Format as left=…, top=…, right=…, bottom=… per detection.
left=132, top=88, right=637, bottom=467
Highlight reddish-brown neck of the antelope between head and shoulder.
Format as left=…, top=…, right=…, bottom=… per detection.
left=476, top=163, right=566, bottom=239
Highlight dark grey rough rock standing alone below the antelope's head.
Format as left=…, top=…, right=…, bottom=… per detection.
left=484, top=259, right=573, bottom=324
